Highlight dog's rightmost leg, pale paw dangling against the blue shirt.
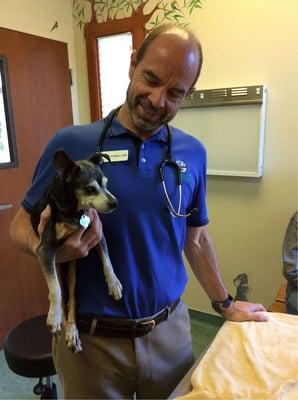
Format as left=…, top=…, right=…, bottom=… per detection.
left=96, top=236, right=122, bottom=300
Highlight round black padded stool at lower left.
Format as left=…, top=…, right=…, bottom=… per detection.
left=4, top=315, right=57, bottom=399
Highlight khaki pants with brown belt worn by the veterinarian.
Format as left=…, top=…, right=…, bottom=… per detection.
left=53, top=303, right=194, bottom=399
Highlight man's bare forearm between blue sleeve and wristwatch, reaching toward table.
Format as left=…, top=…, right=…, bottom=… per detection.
left=184, top=228, right=228, bottom=301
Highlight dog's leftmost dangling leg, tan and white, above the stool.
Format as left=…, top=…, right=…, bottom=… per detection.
left=36, top=221, right=62, bottom=334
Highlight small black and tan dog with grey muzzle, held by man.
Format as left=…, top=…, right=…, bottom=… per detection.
left=31, top=149, right=122, bottom=353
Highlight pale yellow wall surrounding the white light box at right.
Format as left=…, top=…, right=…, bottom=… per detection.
left=185, top=0, right=298, bottom=312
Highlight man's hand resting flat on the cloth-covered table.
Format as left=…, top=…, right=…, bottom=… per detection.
left=222, top=301, right=268, bottom=322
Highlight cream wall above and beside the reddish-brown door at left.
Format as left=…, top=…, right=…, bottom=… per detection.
left=0, top=0, right=80, bottom=123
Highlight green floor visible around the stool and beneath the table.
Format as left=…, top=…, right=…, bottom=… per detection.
left=0, top=310, right=223, bottom=400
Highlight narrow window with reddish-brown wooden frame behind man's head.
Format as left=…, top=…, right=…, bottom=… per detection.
left=85, top=16, right=145, bottom=121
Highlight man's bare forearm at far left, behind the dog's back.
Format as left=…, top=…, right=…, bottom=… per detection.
left=10, top=208, right=39, bottom=255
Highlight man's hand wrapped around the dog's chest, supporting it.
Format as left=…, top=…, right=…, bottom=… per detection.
left=38, top=206, right=102, bottom=263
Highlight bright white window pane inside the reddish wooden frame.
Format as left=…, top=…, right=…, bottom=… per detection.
left=97, top=32, right=132, bottom=117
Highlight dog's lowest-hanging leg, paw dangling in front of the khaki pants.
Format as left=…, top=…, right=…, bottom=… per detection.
left=65, top=261, right=82, bottom=353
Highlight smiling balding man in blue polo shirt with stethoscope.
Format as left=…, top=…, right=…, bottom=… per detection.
left=11, top=25, right=266, bottom=399
